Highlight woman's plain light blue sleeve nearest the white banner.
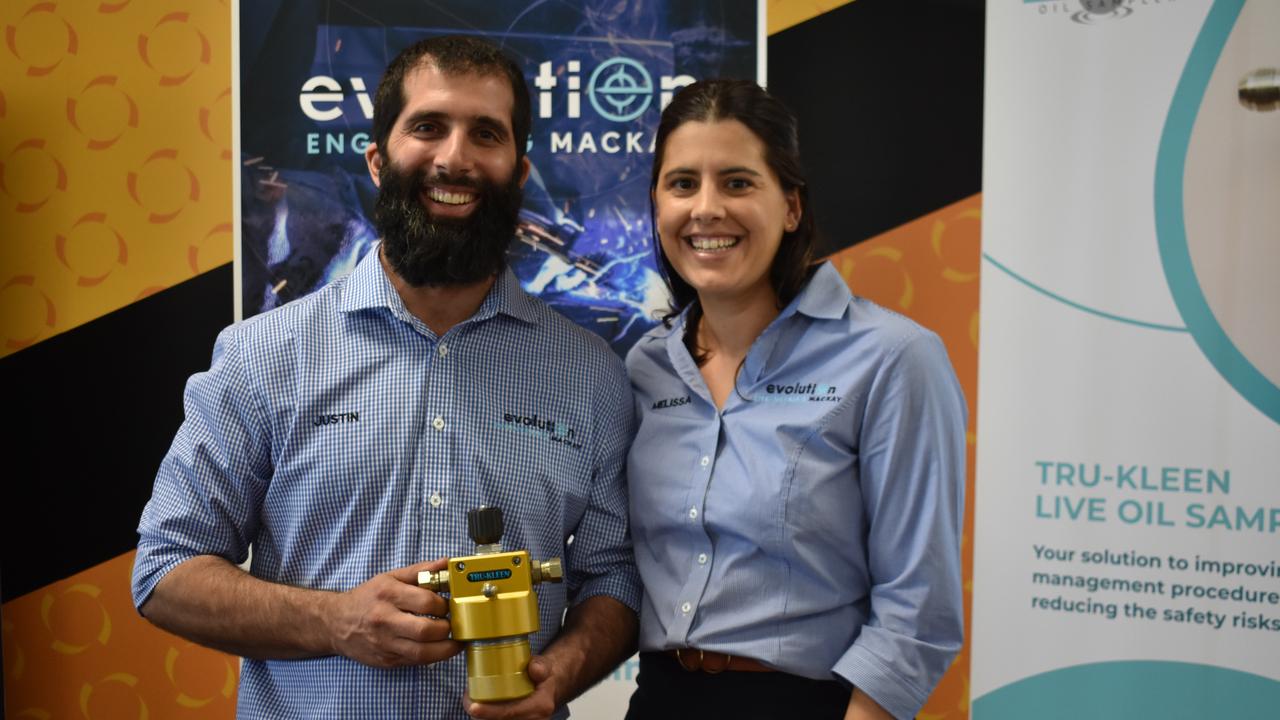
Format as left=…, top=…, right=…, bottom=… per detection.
left=832, top=332, right=966, bottom=717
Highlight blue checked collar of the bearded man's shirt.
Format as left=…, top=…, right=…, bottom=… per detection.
left=338, top=243, right=538, bottom=323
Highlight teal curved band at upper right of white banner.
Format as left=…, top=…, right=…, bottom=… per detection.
left=1155, top=0, right=1280, bottom=423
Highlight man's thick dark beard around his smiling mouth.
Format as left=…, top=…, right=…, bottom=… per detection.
left=374, top=161, right=521, bottom=287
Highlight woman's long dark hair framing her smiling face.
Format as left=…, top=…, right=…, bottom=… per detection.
left=649, top=79, right=818, bottom=365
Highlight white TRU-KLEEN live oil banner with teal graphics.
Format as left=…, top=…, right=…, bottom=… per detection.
left=972, top=0, right=1280, bottom=720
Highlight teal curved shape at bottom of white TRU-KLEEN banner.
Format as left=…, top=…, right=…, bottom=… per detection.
left=973, top=661, right=1280, bottom=720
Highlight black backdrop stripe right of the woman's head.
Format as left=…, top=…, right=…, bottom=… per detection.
left=769, top=0, right=984, bottom=254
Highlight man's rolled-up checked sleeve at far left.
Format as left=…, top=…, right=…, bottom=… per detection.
left=133, top=325, right=271, bottom=609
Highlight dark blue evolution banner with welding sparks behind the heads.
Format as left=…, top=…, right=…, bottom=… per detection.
left=233, top=0, right=764, bottom=352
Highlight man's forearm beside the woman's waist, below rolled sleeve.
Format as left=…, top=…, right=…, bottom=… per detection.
left=543, top=596, right=640, bottom=706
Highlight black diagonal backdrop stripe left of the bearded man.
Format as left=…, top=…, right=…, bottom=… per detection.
left=0, top=264, right=233, bottom=601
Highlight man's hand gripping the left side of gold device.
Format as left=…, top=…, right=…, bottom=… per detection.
left=328, top=559, right=462, bottom=667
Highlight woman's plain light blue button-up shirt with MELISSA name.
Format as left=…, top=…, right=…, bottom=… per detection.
left=627, top=264, right=966, bottom=717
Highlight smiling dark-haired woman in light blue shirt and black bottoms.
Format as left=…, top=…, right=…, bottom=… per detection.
left=627, top=81, right=965, bottom=720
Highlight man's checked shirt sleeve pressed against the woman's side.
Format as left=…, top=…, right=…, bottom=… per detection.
left=564, top=352, right=641, bottom=612
